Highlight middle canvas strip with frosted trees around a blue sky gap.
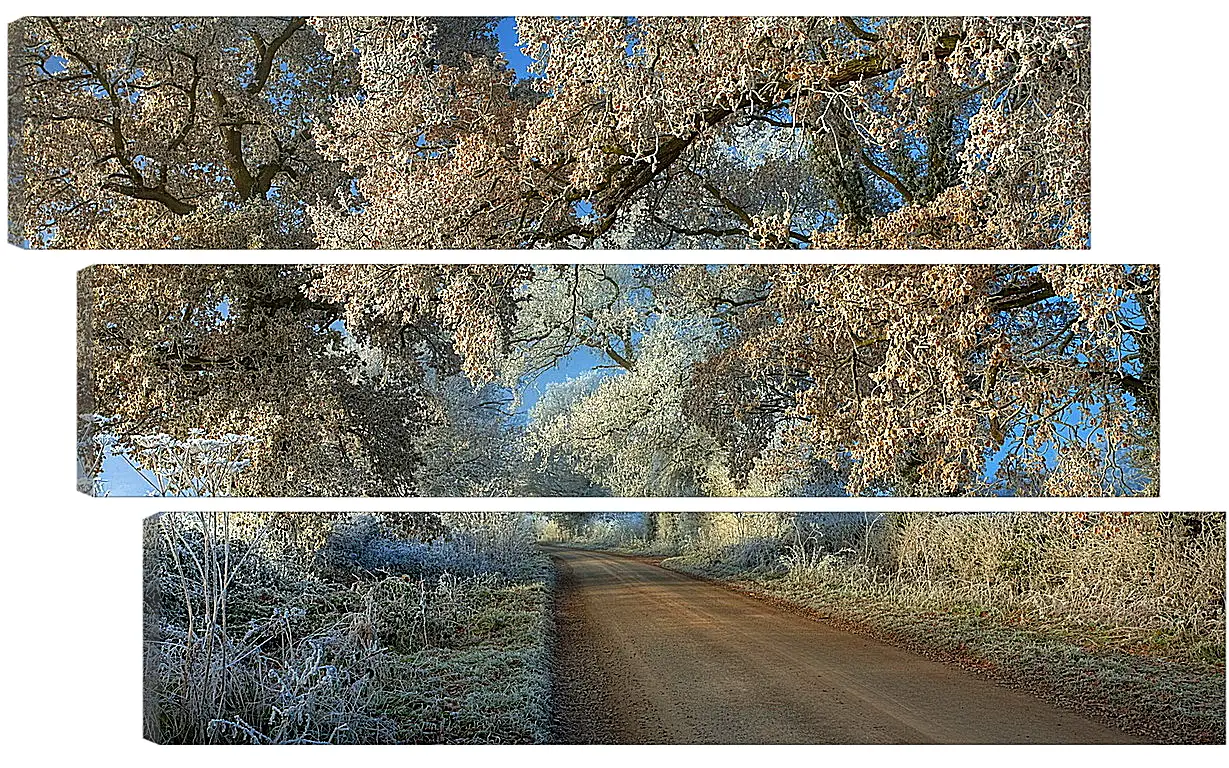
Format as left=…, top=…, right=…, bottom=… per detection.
left=77, top=263, right=1160, bottom=496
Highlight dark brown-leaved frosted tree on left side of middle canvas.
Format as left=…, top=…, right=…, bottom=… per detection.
left=79, top=265, right=528, bottom=495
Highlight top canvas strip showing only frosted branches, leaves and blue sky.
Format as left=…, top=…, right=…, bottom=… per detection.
left=9, top=16, right=1091, bottom=248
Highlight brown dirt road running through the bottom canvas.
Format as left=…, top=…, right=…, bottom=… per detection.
left=551, top=548, right=1134, bottom=743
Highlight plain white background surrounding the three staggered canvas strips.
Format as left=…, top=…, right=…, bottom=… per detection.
left=0, top=0, right=1229, bottom=766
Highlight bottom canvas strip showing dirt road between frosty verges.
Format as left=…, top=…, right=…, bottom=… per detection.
left=144, top=512, right=1225, bottom=743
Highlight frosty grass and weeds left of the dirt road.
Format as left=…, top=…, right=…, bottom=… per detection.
left=145, top=515, right=552, bottom=743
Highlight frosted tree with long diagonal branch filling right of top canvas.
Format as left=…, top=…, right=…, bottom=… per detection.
left=302, top=17, right=1090, bottom=248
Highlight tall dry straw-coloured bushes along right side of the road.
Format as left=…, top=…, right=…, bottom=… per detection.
left=783, top=512, right=1225, bottom=659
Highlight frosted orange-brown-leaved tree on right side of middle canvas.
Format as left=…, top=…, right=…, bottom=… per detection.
left=683, top=265, right=1160, bottom=495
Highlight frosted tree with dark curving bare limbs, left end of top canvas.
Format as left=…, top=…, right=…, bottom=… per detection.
left=10, top=17, right=353, bottom=248
